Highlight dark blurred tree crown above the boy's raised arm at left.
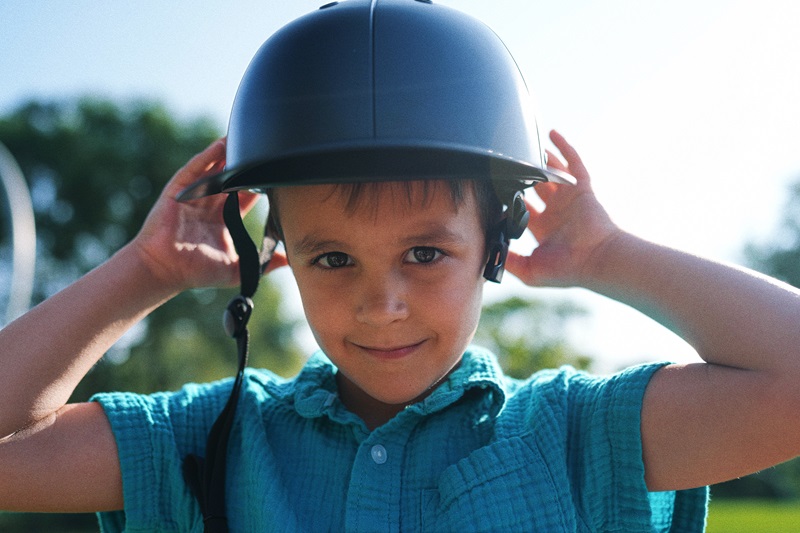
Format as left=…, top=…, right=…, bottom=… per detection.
left=0, top=99, right=218, bottom=271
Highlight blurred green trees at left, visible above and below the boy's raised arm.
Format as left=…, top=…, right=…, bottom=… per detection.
left=0, top=98, right=301, bottom=400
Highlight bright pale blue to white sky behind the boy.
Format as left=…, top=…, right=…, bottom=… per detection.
left=0, top=0, right=800, bottom=370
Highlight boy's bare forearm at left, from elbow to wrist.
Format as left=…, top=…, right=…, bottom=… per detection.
left=0, top=245, right=178, bottom=437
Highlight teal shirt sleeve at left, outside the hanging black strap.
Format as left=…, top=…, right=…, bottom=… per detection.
left=92, top=380, right=230, bottom=533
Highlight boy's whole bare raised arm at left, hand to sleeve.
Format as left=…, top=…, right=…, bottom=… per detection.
left=0, top=141, right=279, bottom=511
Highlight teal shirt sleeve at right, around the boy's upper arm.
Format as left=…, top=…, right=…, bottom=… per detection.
left=562, top=364, right=708, bottom=532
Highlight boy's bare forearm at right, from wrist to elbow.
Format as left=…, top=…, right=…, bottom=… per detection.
left=586, top=233, right=800, bottom=372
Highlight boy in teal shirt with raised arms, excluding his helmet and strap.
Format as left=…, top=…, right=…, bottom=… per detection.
left=0, top=0, right=800, bottom=531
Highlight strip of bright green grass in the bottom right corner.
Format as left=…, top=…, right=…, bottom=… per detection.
left=706, top=499, right=800, bottom=533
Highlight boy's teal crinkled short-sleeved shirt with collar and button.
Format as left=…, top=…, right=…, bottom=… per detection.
left=95, top=348, right=707, bottom=532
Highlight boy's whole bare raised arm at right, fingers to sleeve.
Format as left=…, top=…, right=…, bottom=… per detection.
left=509, top=129, right=800, bottom=490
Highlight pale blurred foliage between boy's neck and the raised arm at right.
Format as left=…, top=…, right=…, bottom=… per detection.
left=475, top=296, right=591, bottom=379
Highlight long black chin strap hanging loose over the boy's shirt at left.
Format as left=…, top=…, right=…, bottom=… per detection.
left=183, top=192, right=277, bottom=533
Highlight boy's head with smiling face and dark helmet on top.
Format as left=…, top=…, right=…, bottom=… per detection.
left=177, top=0, right=570, bottom=416
